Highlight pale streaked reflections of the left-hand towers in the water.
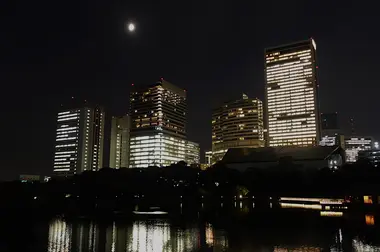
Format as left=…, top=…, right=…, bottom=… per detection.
left=48, top=219, right=227, bottom=252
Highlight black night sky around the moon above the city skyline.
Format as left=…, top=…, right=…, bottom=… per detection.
left=0, top=0, right=380, bottom=180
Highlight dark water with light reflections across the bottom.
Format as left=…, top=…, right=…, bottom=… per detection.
left=0, top=205, right=380, bottom=252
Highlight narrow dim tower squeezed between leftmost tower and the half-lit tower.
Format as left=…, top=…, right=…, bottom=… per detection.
left=109, top=115, right=131, bottom=169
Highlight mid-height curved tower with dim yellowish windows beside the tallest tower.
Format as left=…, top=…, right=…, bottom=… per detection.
left=212, top=94, right=265, bottom=163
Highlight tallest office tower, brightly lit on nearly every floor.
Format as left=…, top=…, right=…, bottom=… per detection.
left=265, top=39, right=320, bottom=146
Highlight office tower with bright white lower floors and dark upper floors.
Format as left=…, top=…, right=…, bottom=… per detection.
left=129, top=79, right=186, bottom=168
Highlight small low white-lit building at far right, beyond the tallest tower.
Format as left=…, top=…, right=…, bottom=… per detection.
left=345, top=137, right=373, bottom=163
